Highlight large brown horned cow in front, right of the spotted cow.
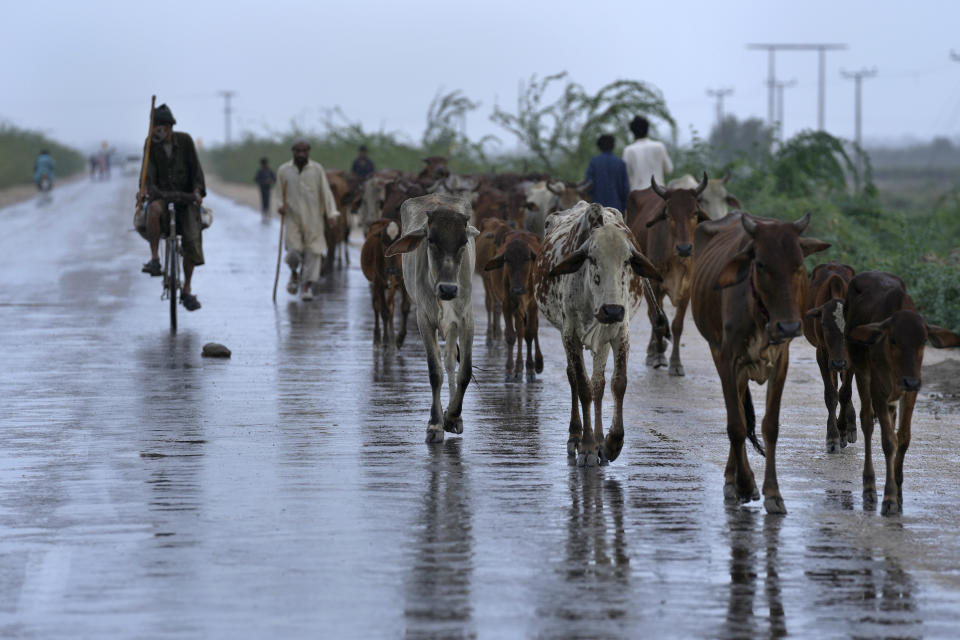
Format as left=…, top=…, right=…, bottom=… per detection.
left=692, top=212, right=830, bottom=513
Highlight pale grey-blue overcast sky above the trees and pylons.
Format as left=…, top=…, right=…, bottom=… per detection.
left=0, top=0, right=960, bottom=150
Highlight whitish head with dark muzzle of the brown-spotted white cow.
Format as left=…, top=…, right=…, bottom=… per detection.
left=550, top=224, right=661, bottom=324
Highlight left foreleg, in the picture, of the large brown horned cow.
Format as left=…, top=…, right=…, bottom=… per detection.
left=711, top=348, right=760, bottom=502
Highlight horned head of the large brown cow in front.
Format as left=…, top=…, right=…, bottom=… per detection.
left=717, top=213, right=830, bottom=344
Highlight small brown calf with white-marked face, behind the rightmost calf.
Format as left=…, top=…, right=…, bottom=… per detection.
left=803, top=262, right=857, bottom=453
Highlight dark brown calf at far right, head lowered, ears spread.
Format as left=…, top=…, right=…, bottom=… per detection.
left=845, top=271, right=960, bottom=515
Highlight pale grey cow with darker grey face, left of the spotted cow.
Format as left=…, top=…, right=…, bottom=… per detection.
left=386, top=193, right=480, bottom=443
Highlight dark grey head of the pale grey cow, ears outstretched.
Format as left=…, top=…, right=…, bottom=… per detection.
left=386, top=208, right=480, bottom=300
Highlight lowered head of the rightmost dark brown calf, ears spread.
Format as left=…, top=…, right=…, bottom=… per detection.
left=849, top=310, right=960, bottom=391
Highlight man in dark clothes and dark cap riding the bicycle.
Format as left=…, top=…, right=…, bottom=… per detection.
left=142, top=104, right=207, bottom=311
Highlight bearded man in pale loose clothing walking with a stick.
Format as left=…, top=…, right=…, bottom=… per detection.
left=277, top=139, right=340, bottom=300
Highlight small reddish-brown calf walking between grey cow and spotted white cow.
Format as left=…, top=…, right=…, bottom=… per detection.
left=484, top=231, right=543, bottom=382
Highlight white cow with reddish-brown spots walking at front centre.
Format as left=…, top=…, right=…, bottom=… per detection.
left=535, top=202, right=660, bottom=466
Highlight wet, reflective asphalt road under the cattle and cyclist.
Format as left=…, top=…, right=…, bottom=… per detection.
left=0, top=179, right=960, bottom=638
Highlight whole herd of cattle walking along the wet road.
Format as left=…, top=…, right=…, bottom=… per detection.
left=318, top=157, right=960, bottom=514
